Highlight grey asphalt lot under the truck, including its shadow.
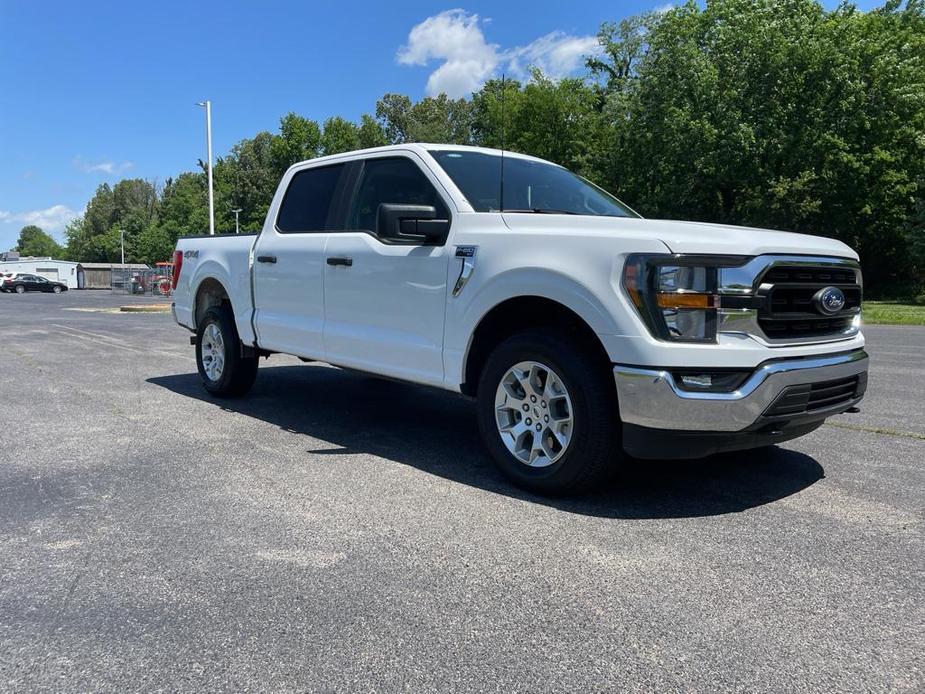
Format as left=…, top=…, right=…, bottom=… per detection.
left=0, top=291, right=925, bottom=692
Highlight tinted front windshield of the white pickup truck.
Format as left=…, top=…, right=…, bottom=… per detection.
left=430, top=150, right=639, bottom=217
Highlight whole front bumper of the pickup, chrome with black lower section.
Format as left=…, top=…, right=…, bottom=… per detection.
left=613, top=349, right=869, bottom=457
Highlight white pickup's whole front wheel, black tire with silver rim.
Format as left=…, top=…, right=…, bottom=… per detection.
left=478, top=332, right=620, bottom=494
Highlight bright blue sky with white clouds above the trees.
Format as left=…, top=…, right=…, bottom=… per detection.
left=0, top=0, right=879, bottom=250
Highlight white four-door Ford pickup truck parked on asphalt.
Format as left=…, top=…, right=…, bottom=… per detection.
left=173, top=144, right=868, bottom=493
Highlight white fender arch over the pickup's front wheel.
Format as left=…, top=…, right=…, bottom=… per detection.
left=459, top=295, right=610, bottom=396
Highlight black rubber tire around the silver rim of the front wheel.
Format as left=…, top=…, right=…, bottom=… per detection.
left=477, top=332, right=622, bottom=495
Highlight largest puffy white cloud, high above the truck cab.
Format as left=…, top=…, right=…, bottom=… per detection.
left=396, top=9, right=598, bottom=98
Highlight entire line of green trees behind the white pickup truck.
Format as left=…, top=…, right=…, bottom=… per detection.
left=18, top=0, right=925, bottom=296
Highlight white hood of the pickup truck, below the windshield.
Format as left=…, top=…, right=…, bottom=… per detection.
left=504, top=212, right=858, bottom=260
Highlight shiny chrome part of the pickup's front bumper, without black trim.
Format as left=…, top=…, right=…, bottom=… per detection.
left=613, top=350, right=868, bottom=432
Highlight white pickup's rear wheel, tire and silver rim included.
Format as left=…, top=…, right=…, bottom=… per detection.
left=196, top=306, right=257, bottom=397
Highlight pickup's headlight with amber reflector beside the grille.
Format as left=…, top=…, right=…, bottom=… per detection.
left=623, top=255, right=741, bottom=342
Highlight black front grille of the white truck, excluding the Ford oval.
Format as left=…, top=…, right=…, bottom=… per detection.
left=758, top=265, right=862, bottom=341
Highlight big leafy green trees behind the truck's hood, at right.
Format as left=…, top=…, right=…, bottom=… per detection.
left=591, top=0, right=925, bottom=291
